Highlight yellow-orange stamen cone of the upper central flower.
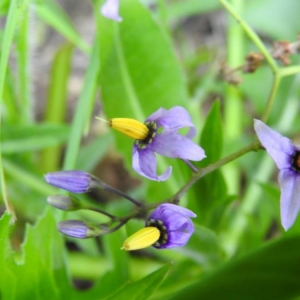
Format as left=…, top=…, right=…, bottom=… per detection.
left=109, top=118, right=149, bottom=140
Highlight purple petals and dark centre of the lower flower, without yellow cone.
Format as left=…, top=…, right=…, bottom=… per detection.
left=145, top=203, right=196, bottom=249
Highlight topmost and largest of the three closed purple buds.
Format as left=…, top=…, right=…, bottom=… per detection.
left=45, top=171, right=99, bottom=194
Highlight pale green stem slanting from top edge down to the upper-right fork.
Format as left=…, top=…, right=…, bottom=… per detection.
left=219, top=0, right=279, bottom=74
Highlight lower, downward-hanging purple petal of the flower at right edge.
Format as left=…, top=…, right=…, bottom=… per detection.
left=278, top=170, right=300, bottom=230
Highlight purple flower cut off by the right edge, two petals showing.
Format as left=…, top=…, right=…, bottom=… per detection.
left=254, top=120, right=300, bottom=230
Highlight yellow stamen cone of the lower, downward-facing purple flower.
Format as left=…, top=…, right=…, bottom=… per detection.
left=121, top=227, right=160, bottom=251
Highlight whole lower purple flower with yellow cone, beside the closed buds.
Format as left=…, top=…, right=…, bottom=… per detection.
left=122, top=203, right=196, bottom=251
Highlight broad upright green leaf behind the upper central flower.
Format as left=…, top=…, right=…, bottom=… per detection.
left=98, top=0, right=187, bottom=201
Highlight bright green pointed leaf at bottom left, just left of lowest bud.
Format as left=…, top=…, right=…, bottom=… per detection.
left=16, top=209, right=71, bottom=299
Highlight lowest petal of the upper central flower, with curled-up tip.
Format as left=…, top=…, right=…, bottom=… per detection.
left=132, top=144, right=172, bottom=181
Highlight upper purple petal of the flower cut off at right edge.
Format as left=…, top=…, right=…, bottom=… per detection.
left=254, top=120, right=295, bottom=169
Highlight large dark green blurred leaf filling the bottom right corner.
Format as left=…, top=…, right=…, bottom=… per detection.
left=171, top=236, right=300, bottom=300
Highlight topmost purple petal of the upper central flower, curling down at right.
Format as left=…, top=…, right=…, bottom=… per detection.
left=147, top=106, right=196, bottom=139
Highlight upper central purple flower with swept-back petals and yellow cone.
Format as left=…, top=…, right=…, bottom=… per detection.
left=109, top=106, right=206, bottom=181
